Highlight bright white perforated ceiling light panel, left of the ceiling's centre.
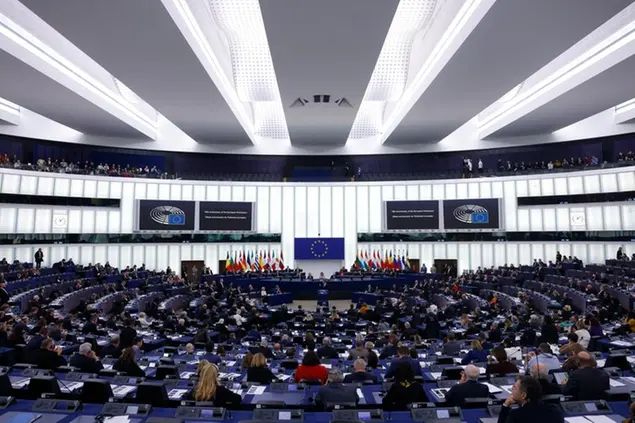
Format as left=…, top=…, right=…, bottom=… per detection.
left=208, top=0, right=289, bottom=140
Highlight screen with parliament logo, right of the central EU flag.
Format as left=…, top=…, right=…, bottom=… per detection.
left=443, top=198, right=500, bottom=229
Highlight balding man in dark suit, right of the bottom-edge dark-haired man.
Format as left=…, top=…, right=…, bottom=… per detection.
left=562, top=351, right=611, bottom=401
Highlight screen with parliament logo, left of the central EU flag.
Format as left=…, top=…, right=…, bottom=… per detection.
left=137, top=200, right=196, bottom=231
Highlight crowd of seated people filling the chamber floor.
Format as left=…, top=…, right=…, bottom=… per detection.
left=0, top=257, right=635, bottom=422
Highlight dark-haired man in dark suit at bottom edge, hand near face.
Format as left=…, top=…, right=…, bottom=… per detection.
left=498, top=376, right=564, bottom=423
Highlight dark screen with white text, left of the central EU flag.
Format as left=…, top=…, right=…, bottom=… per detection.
left=199, top=201, right=254, bottom=232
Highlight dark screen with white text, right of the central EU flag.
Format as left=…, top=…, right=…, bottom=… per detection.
left=385, top=201, right=439, bottom=231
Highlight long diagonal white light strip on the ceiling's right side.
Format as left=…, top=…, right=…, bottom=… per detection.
left=478, top=21, right=635, bottom=138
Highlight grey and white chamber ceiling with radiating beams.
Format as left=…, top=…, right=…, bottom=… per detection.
left=0, top=0, right=635, bottom=154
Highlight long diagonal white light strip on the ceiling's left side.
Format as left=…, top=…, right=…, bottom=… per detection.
left=0, top=14, right=157, bottom=139
